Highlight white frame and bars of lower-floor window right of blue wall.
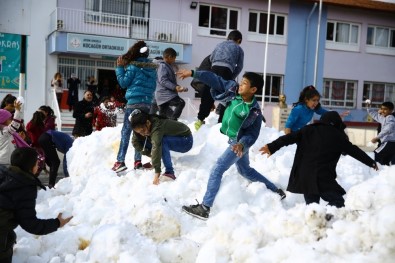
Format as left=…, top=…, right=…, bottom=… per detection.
left=320, top=78, right=358, bottom=109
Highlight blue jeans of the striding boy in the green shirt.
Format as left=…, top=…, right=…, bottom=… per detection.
left=203, top=140, right=278, bottom=207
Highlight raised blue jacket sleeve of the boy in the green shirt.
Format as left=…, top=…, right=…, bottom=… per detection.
left=193, top=70, right=239, bottom=103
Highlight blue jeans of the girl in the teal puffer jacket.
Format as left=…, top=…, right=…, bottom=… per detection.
left=117, top=105, right=149, bottom=162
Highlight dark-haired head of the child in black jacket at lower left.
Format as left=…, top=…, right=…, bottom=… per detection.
left=11, top=147, right=38, bottom=173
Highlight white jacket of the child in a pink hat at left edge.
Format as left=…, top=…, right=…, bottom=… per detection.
left=0, top=110, right=21, bottom=164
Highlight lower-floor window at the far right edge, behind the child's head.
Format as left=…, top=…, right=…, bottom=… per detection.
left=362, top=82, right=395, bottom=108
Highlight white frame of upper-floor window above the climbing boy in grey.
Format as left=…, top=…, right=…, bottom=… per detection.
left=197, top=3, right=241, bottom=38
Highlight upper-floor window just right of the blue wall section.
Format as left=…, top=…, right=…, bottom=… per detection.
left=326, top=21, right=360, bottom=51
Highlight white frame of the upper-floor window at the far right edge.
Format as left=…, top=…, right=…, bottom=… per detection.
left=366, top=25, right=395, bottom=56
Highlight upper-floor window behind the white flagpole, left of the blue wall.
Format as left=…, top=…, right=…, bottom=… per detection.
left=247, top=11, right=287, bottom=44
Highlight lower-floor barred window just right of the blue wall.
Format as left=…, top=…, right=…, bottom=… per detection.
left=321, top=79, right=357, bottom=108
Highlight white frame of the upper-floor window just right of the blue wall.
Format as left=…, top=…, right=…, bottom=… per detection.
left=325, top=19, right=362, bottom=52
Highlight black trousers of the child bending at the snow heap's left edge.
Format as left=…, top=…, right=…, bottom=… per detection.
left=38, top=133, right=60, bottom=186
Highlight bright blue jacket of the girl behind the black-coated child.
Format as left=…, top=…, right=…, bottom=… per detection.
left=285, top=103, right=327, bottom=131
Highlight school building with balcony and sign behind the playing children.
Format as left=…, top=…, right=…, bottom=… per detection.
left=0, top=0, right=395, bottom=140
